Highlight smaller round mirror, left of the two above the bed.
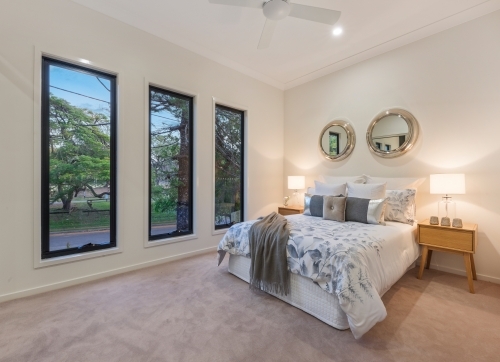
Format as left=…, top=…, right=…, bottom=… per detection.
left=319, top=120, right=356, bottom=161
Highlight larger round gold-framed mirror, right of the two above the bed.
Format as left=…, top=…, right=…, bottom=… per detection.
left=366, top=108, right=418, bottom=158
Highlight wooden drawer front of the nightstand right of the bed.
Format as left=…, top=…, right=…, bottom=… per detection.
left=419, top=226, right=474, bottom=251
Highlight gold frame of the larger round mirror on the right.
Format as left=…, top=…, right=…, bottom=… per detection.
left=366, top=108, right=419, bottom=158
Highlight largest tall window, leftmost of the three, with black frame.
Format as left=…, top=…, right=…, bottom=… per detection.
left=41, top=57, right=116, bottom=259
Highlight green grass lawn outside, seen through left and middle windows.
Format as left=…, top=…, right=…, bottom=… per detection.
left=50, top=197, right=176, bottom=232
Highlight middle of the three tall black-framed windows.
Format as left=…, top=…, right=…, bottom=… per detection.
left=149, top=86, right=193, bottom=240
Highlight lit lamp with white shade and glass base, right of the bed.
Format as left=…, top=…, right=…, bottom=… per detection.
left=430, top=173, right=465, bottom=226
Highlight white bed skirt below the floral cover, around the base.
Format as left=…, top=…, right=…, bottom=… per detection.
left=228, top=255, right=349, bottom=330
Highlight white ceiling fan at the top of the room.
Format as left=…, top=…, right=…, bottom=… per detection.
left=208, top=0, right=340, bottom=49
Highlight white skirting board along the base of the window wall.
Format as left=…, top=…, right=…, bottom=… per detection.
left=0, top=246, right=217, bottom=303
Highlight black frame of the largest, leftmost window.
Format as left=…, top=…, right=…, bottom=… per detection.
left=41, top=56, right=117, bottom=259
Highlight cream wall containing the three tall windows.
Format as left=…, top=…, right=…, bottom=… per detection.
left=0, top=0, right=284, bottom=301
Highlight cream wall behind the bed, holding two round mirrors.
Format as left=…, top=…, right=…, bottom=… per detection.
left=284, top=12, right=500, bottom=282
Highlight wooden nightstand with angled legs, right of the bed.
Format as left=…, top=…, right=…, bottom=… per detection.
left=417, top=220, right=477, bottom=293
